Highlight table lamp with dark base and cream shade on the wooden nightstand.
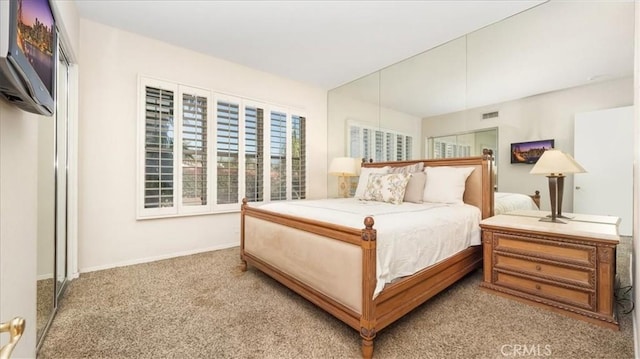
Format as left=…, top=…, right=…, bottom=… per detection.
left=529, top=149, right=587, bottom=223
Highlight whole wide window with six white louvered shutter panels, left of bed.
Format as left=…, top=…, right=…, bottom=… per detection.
left=138, top=77, right=306, bottom=218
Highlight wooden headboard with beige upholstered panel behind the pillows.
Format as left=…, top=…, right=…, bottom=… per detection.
left=362, top=155, right=494, bottom=218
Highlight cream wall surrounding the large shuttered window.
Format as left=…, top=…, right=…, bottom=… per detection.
left=78, top=19, right=327, bottom=272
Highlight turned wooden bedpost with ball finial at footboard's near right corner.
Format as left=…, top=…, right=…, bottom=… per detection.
left=360, top=217, right=377, bottom=359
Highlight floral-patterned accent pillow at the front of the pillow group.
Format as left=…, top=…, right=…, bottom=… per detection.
left=363, top=173, right=411, bottom=204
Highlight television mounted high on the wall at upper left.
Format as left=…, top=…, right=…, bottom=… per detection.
left=0, top=0, right=57, bottom=116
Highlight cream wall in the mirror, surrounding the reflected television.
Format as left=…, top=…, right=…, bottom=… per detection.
left=422, top=77, right=633, bottom=212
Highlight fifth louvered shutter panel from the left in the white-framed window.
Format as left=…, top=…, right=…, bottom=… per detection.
left=270, top=111, right=287, bottom=201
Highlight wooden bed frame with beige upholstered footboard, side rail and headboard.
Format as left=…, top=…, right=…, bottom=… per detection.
left=240, top=156, right=494, bottom=358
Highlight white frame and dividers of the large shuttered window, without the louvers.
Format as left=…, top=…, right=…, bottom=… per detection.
left=136, top=75, right=309, bottom=219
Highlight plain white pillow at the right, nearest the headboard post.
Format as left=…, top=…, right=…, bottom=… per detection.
left=422, top=166, right=474, bottom=204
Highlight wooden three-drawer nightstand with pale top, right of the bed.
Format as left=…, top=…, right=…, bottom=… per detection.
left=480, top=211, right=620, bottom=330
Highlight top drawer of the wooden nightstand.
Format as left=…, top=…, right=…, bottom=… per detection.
left=494, top=233, right=596, bottom=266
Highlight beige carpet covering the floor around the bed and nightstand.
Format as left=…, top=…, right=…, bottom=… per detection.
left=39, top=240, right=634, bottom=359
